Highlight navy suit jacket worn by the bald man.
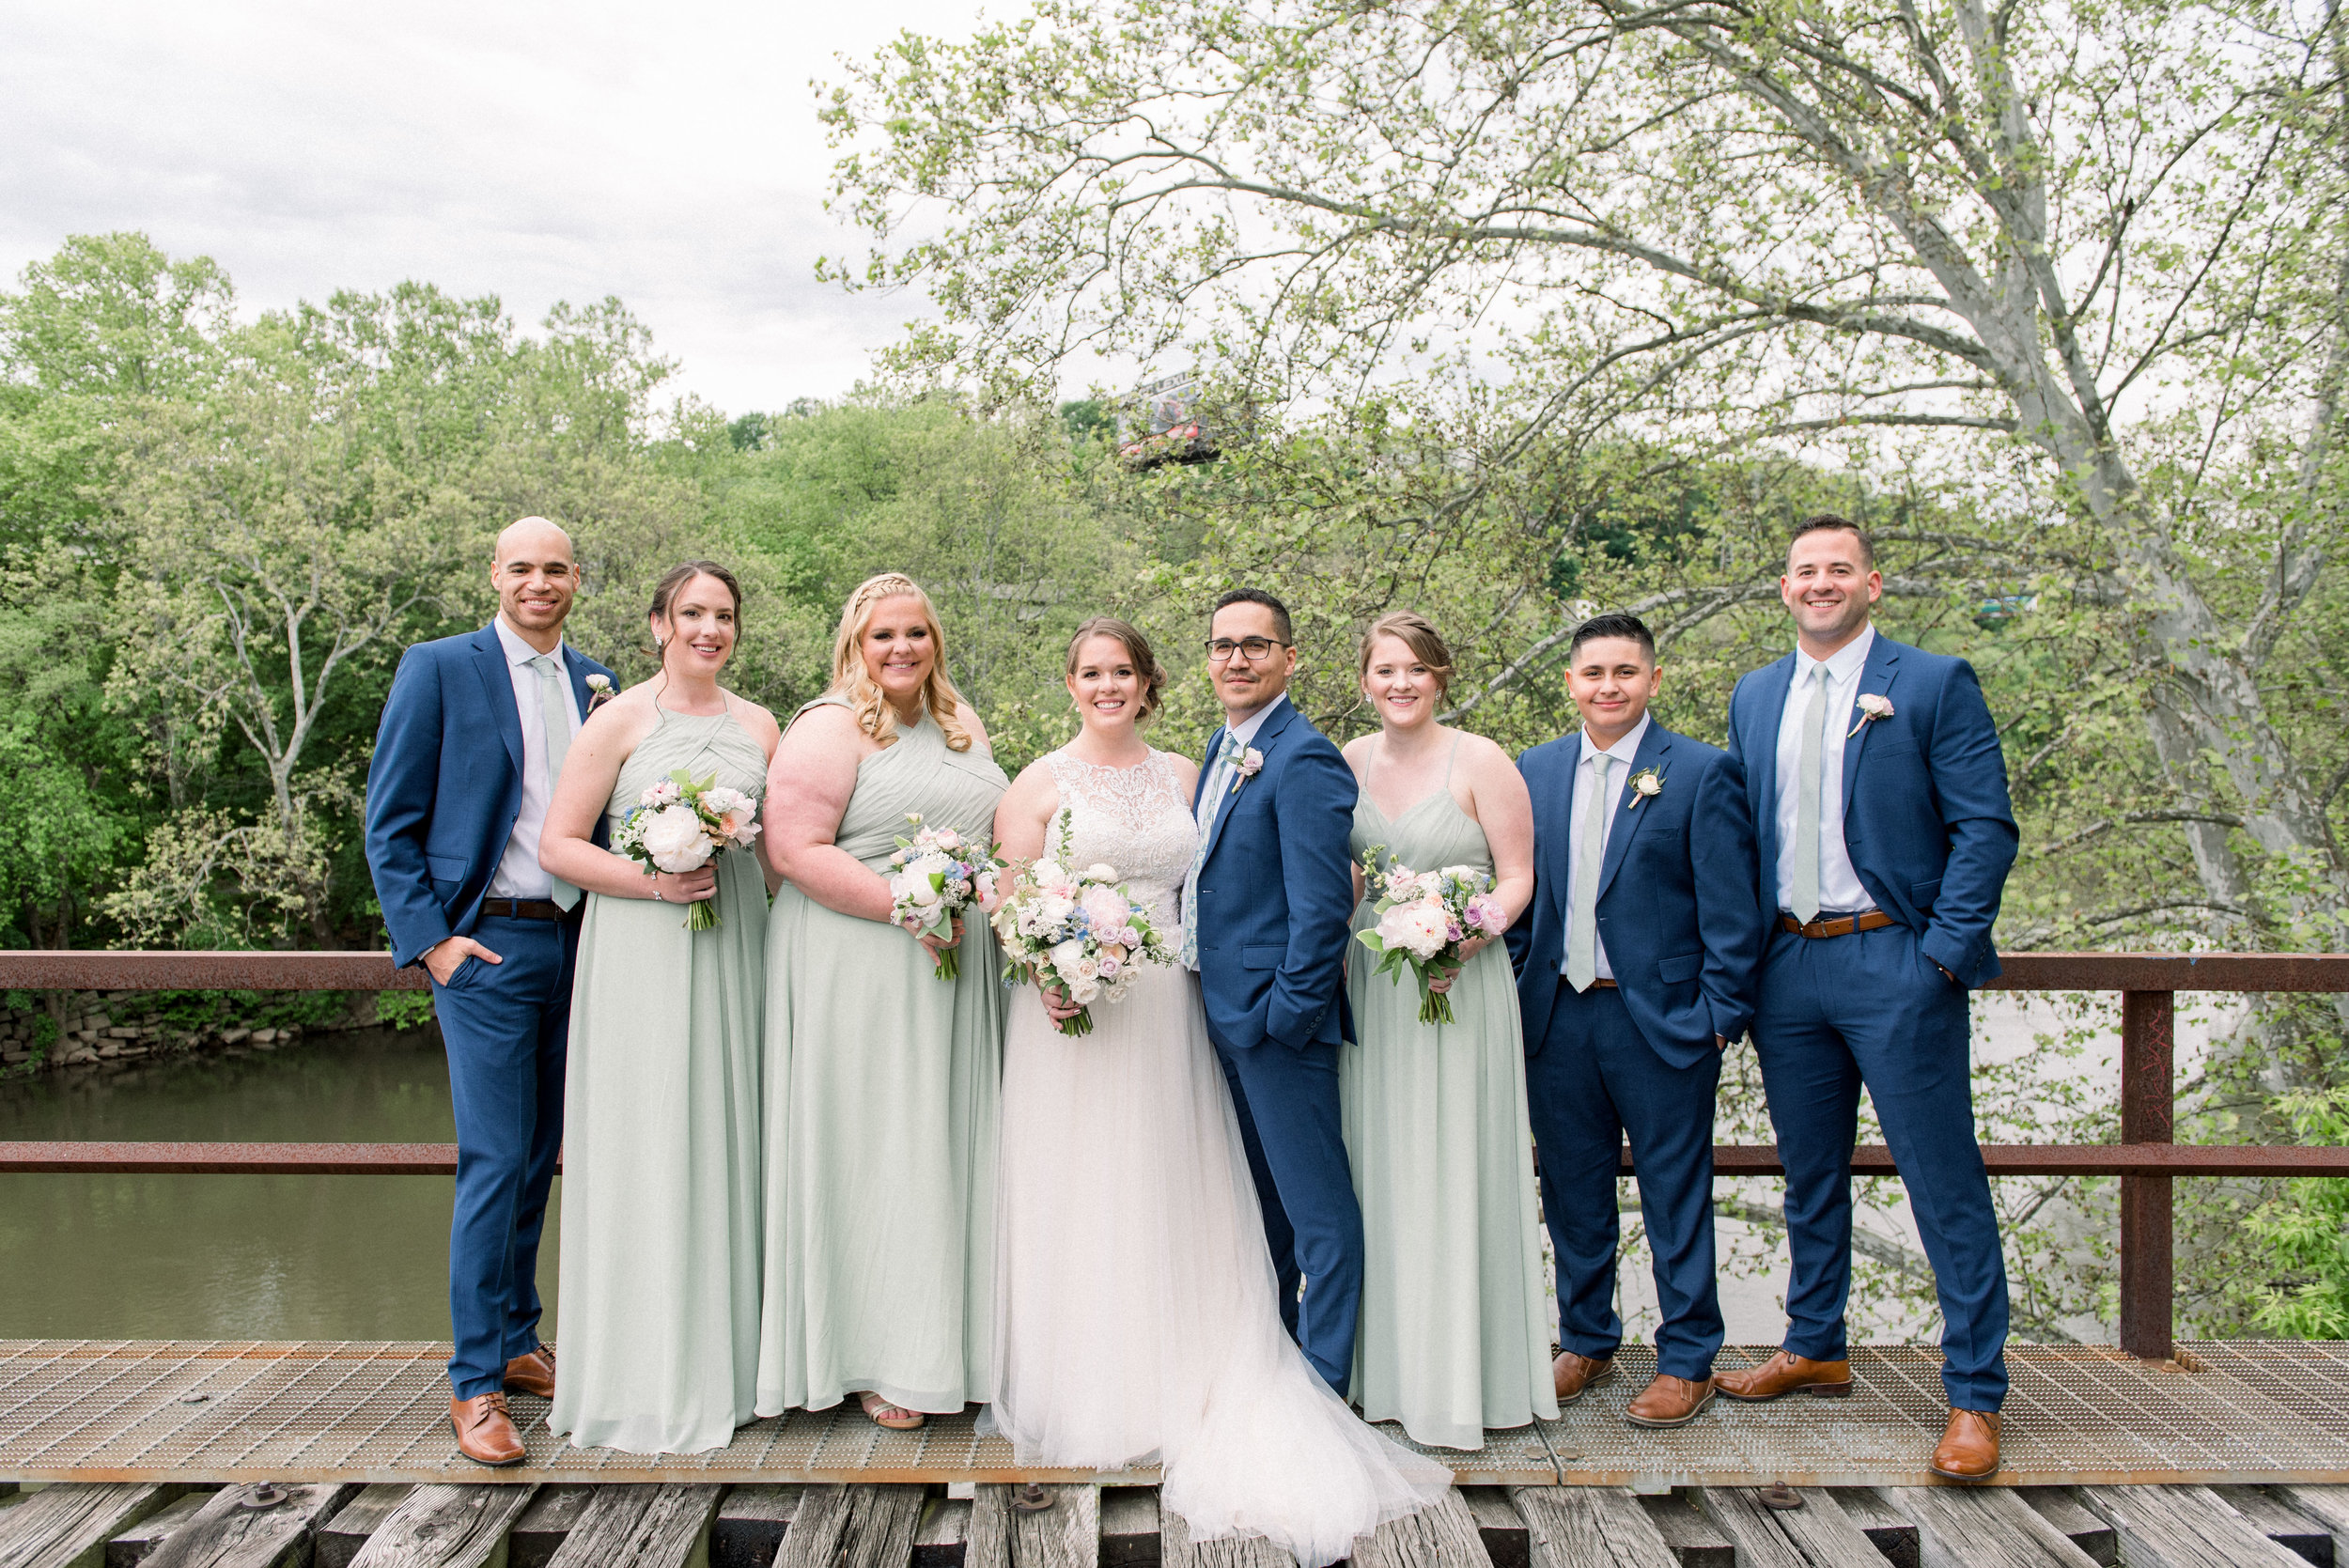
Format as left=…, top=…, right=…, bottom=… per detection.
left=366, top=625, right=611, bottom=965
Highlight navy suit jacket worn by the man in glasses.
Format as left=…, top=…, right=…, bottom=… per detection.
left=1184, top=702, right=1356, bottom=1049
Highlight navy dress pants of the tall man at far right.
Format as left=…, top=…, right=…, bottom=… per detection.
left=1755, top=924, right=2006, bottom=1411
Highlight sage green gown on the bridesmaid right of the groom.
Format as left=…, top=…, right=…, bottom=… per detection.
left=1339, top=742, right=1558, bottom=1449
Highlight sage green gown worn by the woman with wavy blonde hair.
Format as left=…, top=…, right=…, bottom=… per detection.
left=759, top=697, right=1008, bottom=1416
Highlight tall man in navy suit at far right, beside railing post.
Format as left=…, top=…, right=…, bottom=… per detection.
left=1719, top=517, right=2015, bottom=1482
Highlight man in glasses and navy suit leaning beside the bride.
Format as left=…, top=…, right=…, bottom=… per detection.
left=1182, top=589, right=1362, bottom=1394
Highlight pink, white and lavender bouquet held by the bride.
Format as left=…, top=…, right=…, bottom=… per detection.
left=994, top=812, right=1174, bottom=1035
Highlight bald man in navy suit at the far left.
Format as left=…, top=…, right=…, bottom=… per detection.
left=366, top=517, right=611, bottom=1465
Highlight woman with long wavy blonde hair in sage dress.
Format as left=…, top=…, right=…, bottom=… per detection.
left=759, top=573, right=1008, bottom=1430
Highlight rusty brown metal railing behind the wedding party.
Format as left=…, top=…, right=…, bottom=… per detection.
left=0, top=951, right=2349, bottom=1359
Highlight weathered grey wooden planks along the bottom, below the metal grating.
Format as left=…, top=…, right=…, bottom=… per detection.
left=0, top=1483, right=2349, bottom=1568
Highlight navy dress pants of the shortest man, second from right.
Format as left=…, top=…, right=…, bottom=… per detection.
left=1525, top=981, right=1722, bottom=1383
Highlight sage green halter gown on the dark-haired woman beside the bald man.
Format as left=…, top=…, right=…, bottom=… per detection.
left=548, top=709, right=769, bottom=1453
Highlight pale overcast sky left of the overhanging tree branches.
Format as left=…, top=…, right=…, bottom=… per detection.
left=0, top=0, right=972, bottom=413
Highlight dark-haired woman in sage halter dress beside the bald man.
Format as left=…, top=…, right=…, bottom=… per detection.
left=538, top=561, right=780, bottom=1453
